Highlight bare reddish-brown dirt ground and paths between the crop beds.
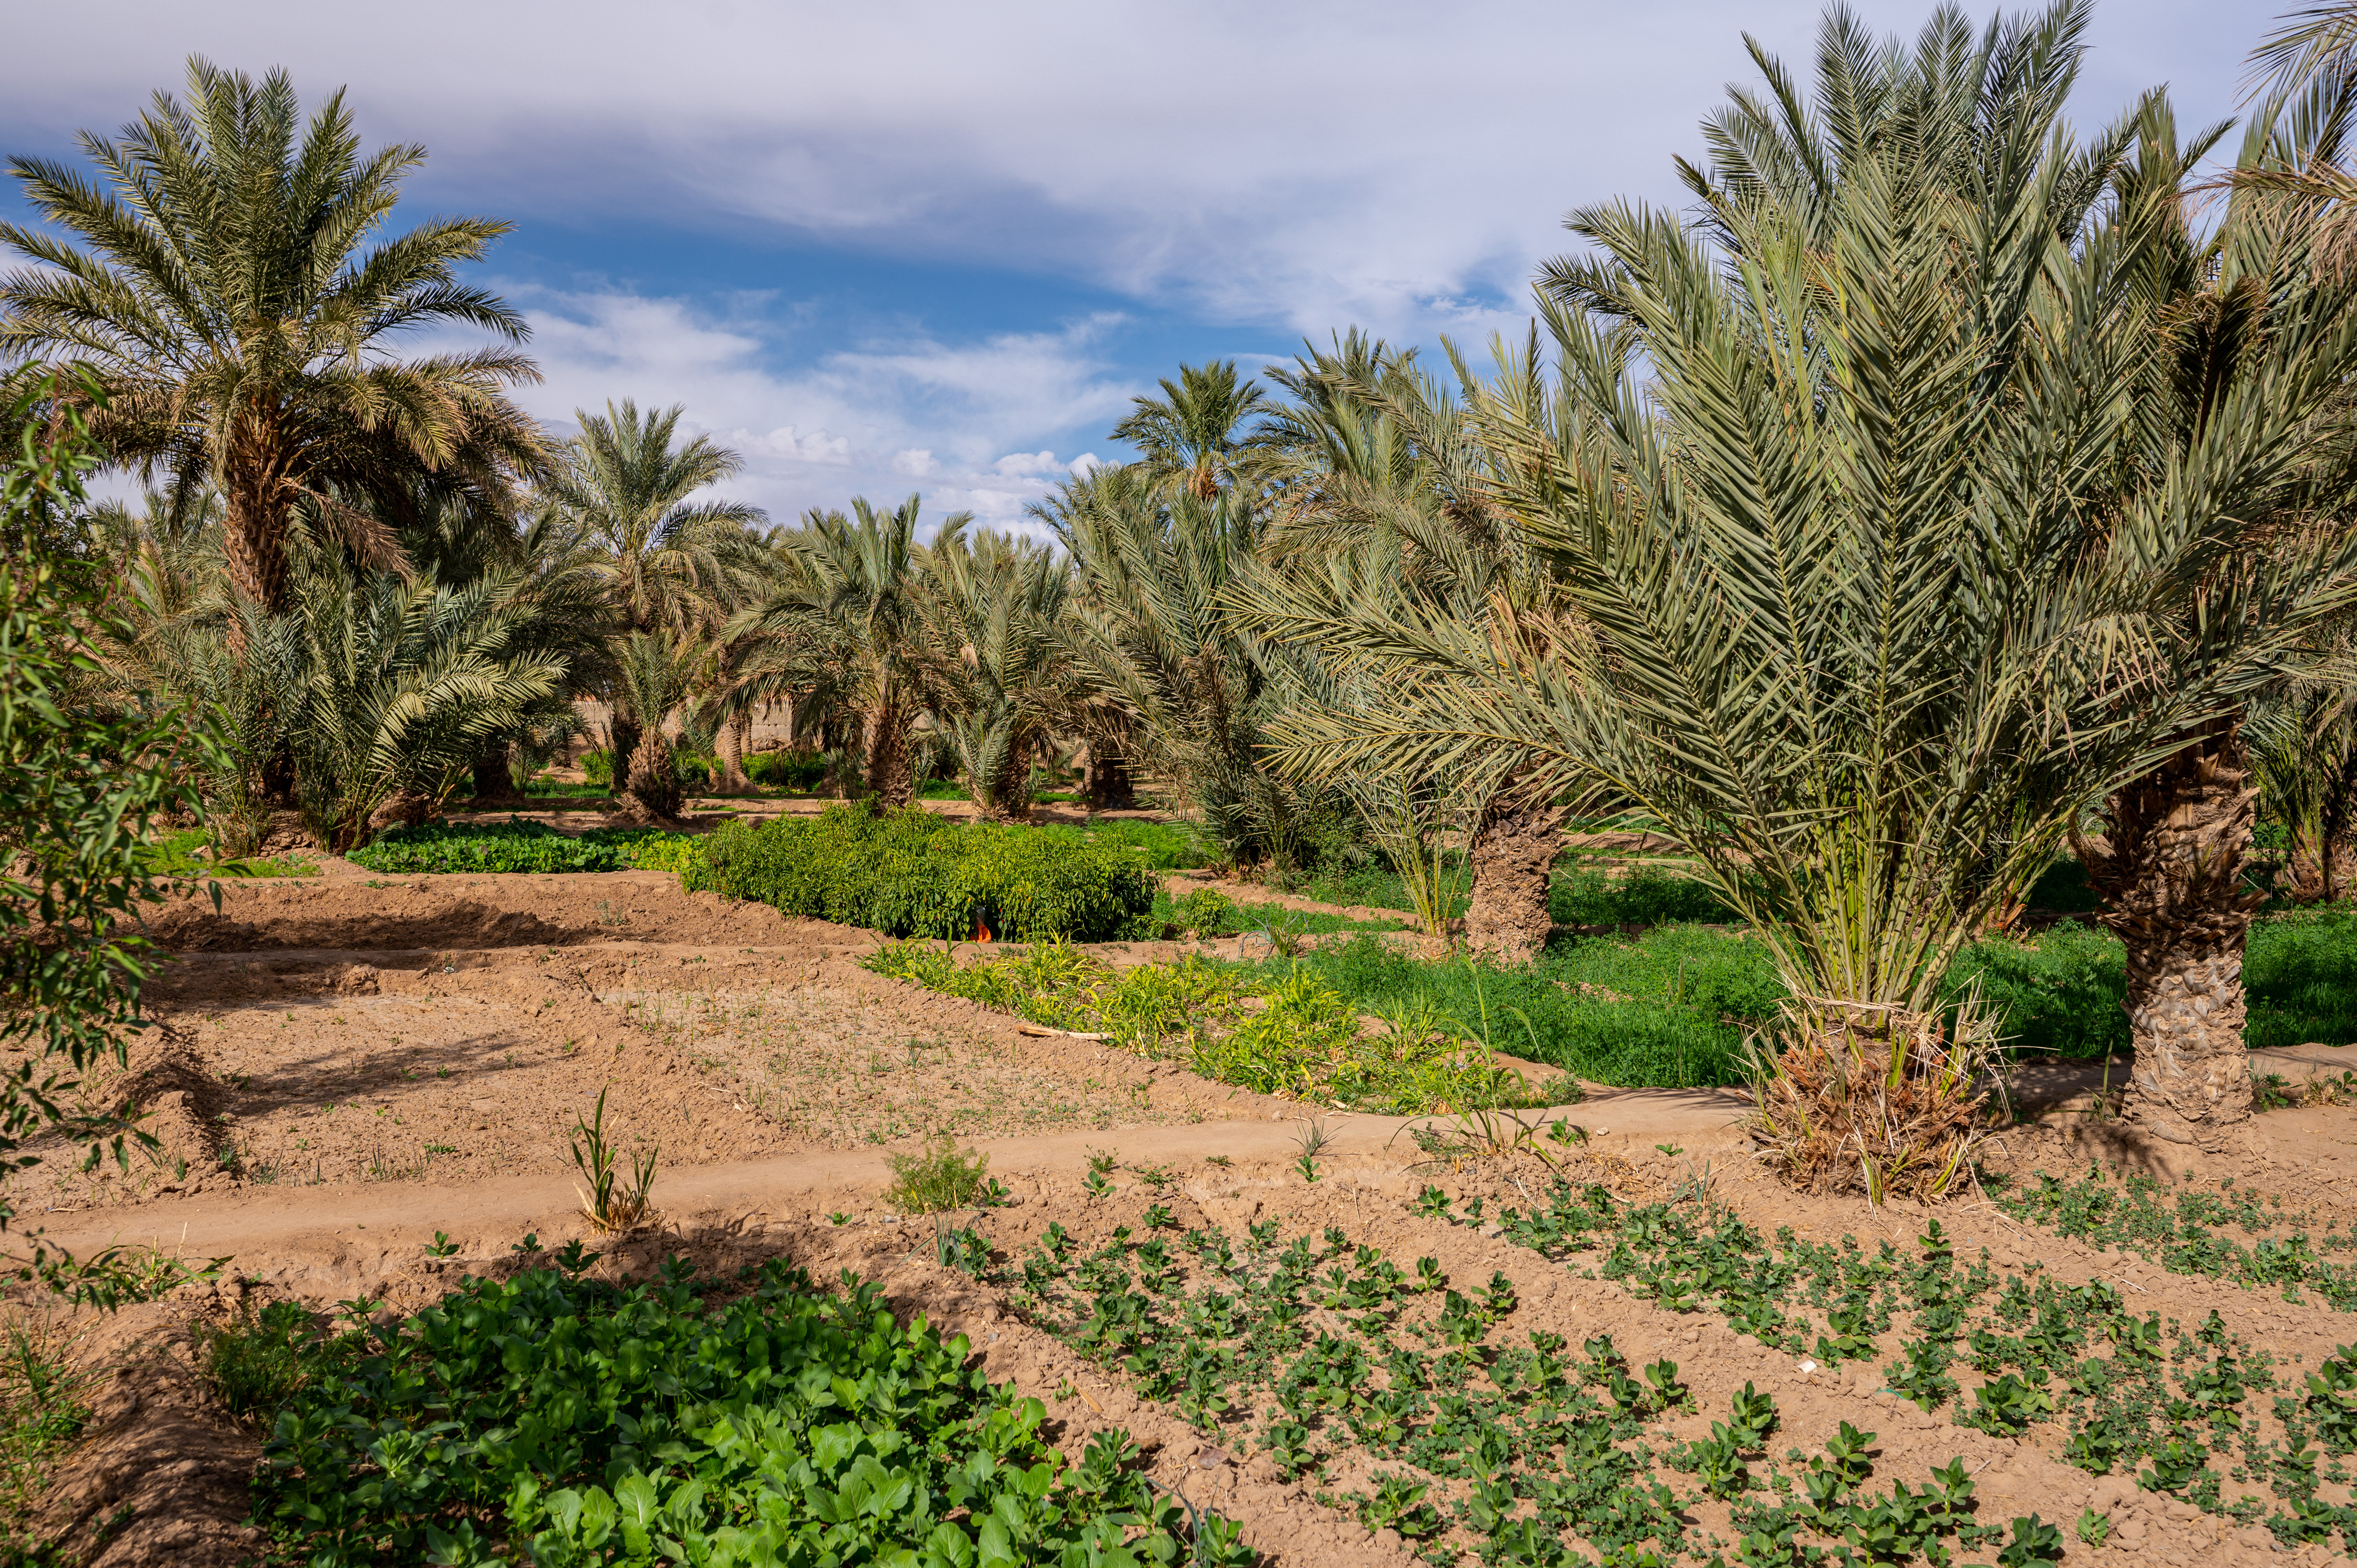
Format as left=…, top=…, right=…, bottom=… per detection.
left=16, top=865, right=2357, bottom=1568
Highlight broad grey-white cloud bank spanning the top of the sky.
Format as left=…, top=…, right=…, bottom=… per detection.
left=0, top=0, right=2263, bottom=342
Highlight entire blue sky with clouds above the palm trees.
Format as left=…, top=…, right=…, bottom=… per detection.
left=0, top=0, right=2274, bottom=526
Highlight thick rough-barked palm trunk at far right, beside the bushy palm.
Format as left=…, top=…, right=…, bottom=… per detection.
left=2072, top=722, right=2263, bottom=1151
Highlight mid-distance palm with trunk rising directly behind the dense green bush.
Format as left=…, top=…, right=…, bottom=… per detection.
left=726, top=495, right=974, bottom=811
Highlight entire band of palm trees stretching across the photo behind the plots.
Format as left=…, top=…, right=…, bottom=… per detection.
left=0, top=0, right=2357, bottom=1193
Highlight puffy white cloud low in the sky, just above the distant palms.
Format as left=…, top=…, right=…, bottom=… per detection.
left=507, top=285, right=1136, bottom=528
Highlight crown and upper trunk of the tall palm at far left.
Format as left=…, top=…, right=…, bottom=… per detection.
left=0, top=59, right=542, bottom=625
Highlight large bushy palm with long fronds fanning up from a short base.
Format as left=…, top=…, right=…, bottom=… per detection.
left=1259, top=49, right=2357, bottom=1195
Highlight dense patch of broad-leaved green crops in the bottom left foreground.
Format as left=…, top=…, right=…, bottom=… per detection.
left=239, top=1243, right=1251, bottom=1568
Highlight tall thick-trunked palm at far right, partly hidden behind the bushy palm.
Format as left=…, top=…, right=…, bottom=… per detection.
left=1593, top=0, right=2357, bottom=1144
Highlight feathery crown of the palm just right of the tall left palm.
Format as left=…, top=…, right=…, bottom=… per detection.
left=547, top=399, right=769, bottom=637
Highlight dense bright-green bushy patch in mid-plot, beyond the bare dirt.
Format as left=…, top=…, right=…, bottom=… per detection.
left=691, top=806, right=1157, bottom=941
